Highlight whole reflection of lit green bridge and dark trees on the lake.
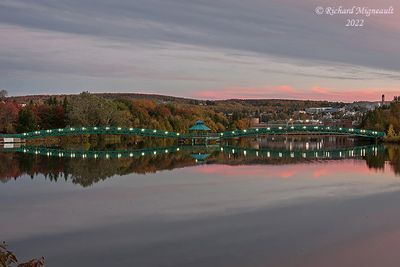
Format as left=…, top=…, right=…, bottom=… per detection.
left=0, top=142, right=400, bottom=186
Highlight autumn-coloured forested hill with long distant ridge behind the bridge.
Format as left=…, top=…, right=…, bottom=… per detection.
left=0, top=92, right=344, bottom=133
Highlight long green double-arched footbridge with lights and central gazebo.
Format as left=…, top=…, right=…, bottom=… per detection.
left=0, top=125, right=385, bottom=143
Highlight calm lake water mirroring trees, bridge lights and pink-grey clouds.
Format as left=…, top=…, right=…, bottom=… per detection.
left=0, top=140, right=400, bottom=267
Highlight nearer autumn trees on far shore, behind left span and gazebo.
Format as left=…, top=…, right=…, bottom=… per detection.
left=0, top=92, right=250, bottom=133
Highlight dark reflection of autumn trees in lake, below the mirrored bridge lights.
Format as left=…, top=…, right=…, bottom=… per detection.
left=0, top=146, right=400, bottom=187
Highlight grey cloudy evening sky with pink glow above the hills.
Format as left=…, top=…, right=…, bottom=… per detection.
left=0, top=0, right=400, bottom=102
